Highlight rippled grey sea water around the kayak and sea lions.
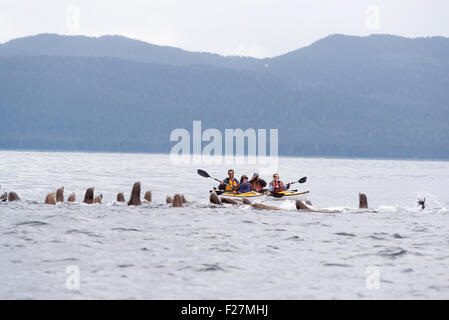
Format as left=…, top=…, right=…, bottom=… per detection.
left=0, top=151, right=449, bottom=299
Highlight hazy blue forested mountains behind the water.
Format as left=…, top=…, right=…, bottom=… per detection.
left=0, top=34, right=449, bottom=159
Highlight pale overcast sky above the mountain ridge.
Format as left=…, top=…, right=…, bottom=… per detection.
left=0, top=0, right=449, bottom=57
